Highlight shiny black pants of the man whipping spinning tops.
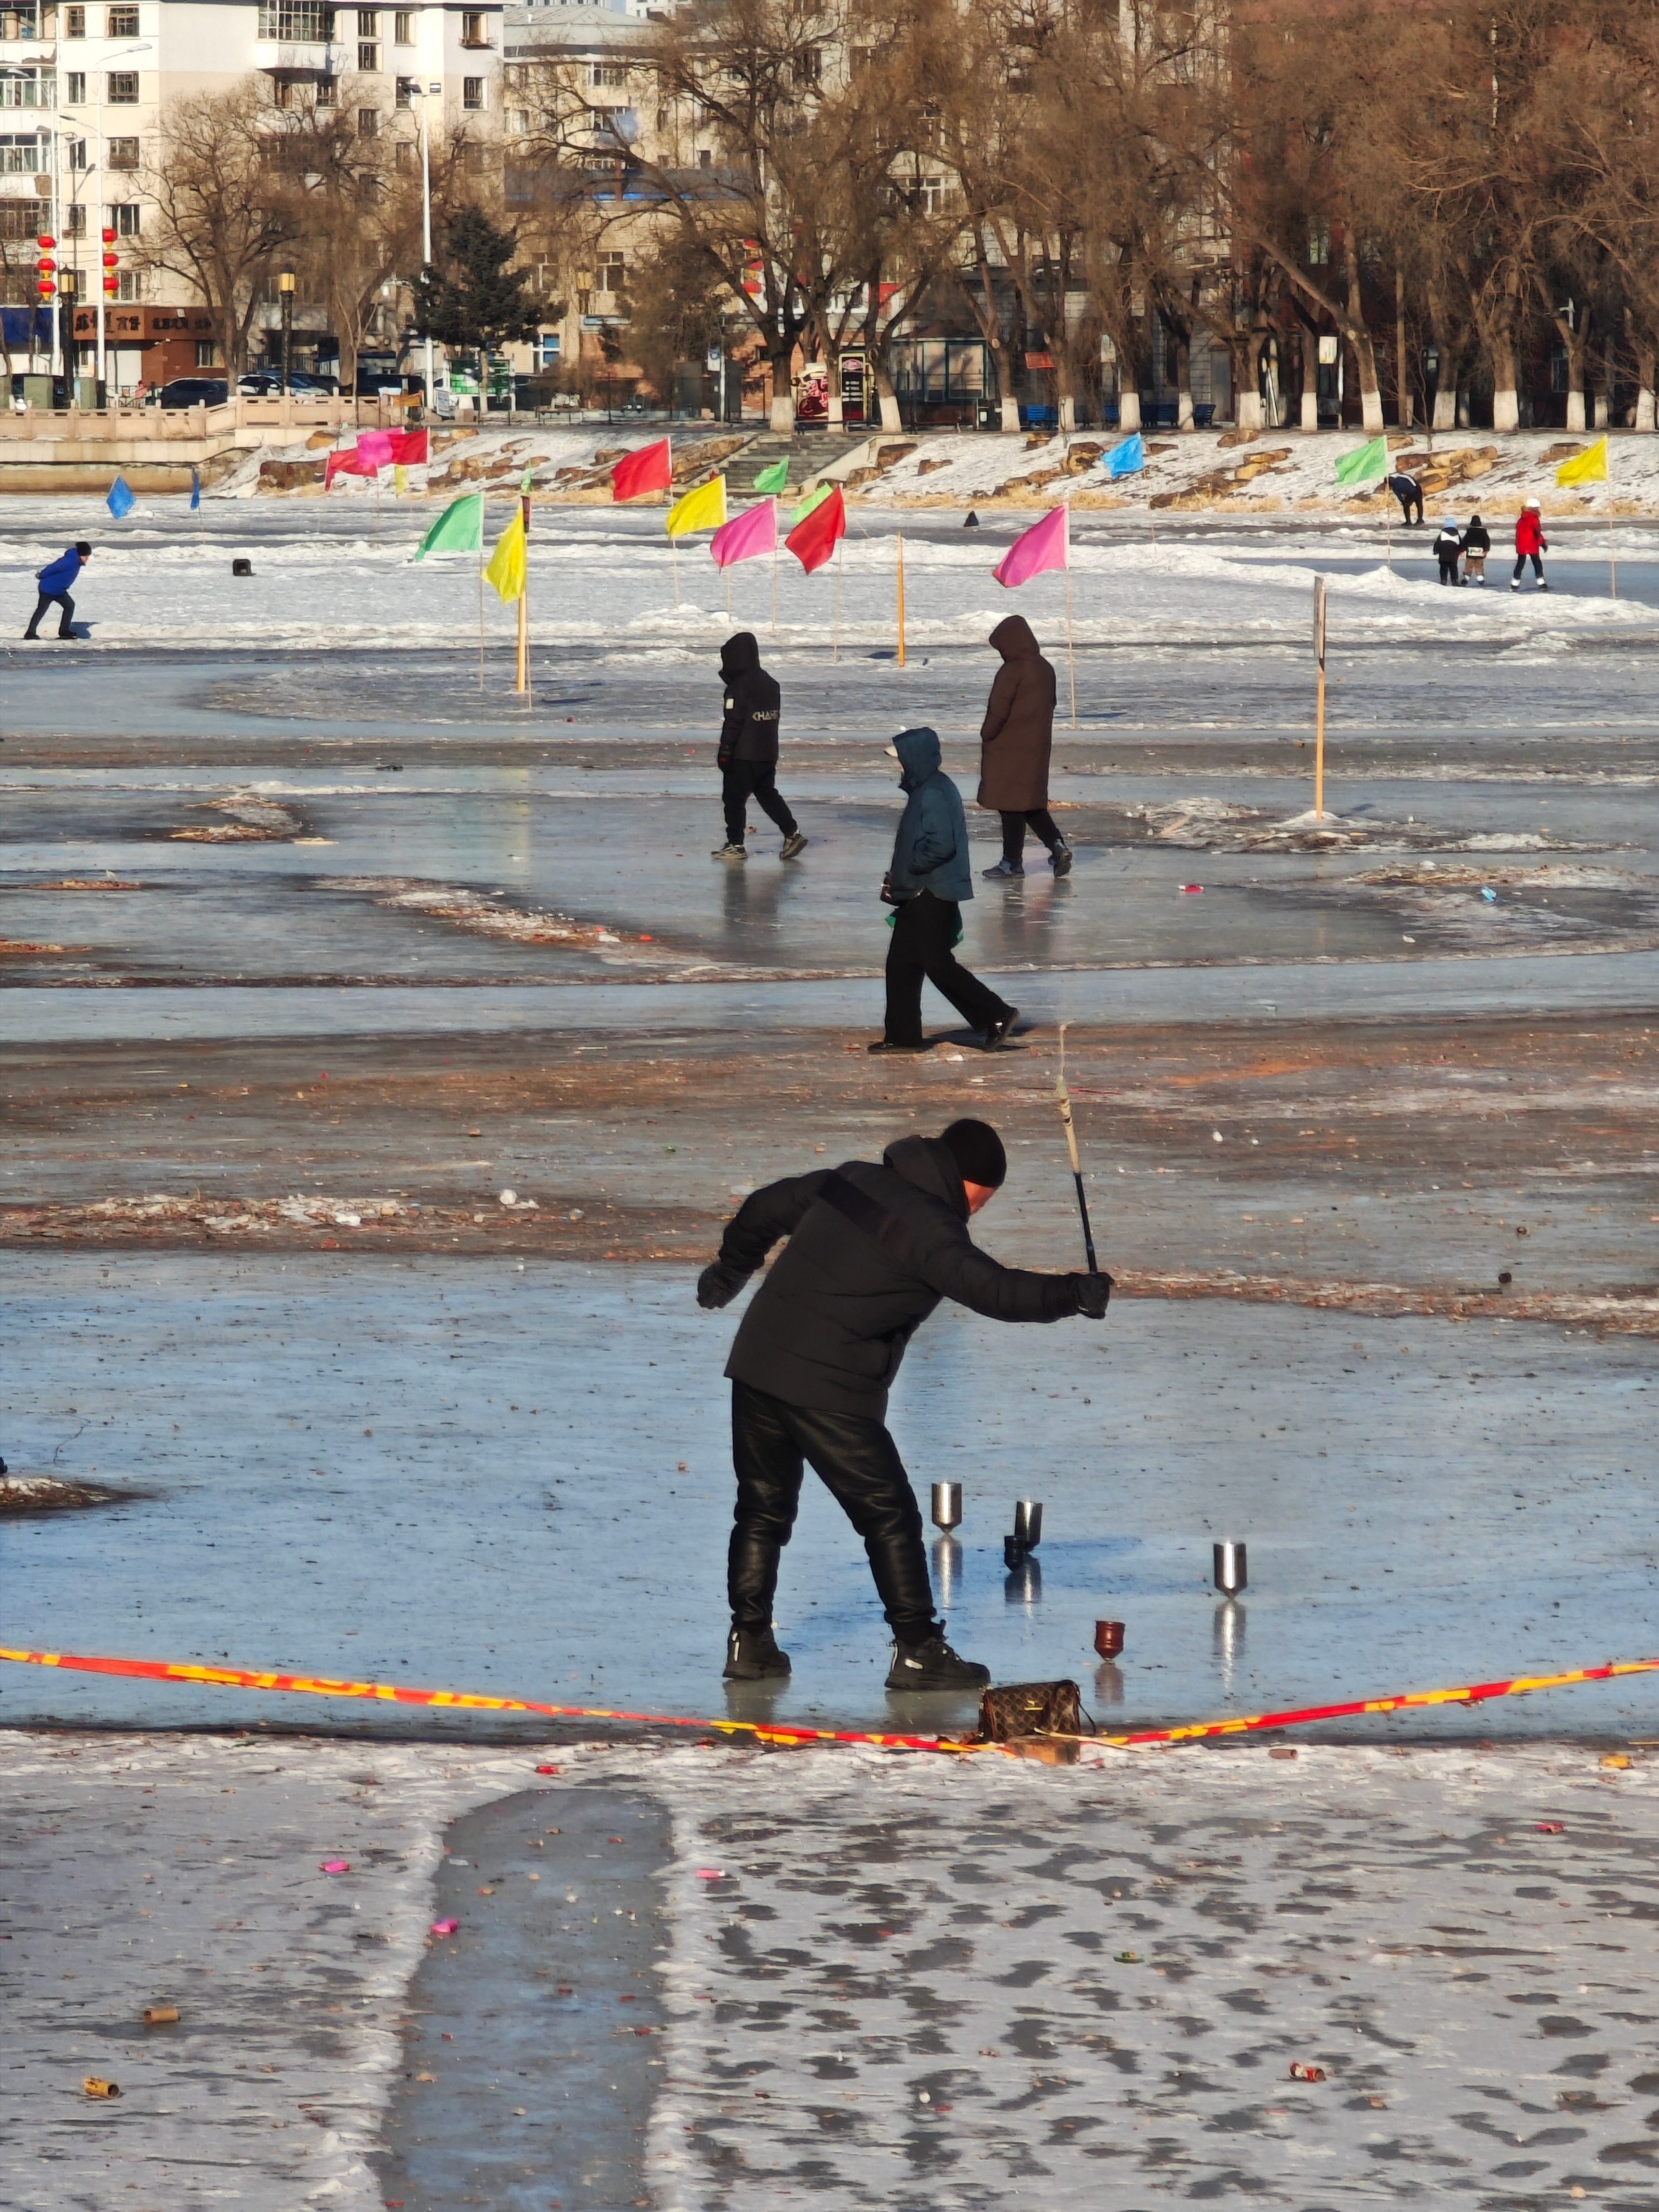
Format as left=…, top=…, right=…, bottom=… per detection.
left=725, top=1382, right=938, bottom=1643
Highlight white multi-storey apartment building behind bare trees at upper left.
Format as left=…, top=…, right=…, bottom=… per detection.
left=0, top=0, right=502, bottom=389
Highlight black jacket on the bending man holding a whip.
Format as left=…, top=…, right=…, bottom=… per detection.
left=721, top=1137, right=1077, bottom=1420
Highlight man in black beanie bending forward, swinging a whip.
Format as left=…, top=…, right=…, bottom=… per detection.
left=697, top=1122, right=1110, bottom=1690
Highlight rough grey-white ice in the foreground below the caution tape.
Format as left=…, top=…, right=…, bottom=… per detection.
left=0, top=1734, right=1655, bottom=2212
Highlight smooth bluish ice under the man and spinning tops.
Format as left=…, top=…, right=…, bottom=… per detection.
left=0, top=1256, right=1659, bottom=1734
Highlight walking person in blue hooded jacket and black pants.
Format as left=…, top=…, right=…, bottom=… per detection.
left=869, top=730, right=1020, bottom=1053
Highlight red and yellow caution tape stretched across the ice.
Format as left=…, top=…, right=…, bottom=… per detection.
left=0, top=1648, right=1659, bottom=1752
